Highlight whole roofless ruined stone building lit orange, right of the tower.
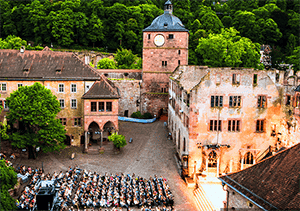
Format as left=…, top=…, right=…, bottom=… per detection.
left=168, top=66, right=299, bottom=180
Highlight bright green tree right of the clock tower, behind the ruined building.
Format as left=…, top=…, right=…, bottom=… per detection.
left=196, top=28, right=260, bottom=68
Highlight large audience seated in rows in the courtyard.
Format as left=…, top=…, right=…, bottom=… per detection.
left=17, top=167, right=174, bottom=211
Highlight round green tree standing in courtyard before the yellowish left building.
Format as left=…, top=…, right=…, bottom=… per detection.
left=7, top=83, right=66, bottom=158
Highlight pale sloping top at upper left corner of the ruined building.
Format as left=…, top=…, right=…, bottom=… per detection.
left=171, top=65, right=208, bottom=93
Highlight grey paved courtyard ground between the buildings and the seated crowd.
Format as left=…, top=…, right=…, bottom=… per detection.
left=8, top=121, right=197, bottom=211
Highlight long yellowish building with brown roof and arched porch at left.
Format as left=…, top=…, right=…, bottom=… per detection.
left=0, top=47, right=119, bottom=145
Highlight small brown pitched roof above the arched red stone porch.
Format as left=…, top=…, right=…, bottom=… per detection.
left=82, top=75, right=120, bottom=99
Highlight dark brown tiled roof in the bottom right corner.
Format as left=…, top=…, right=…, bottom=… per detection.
left=220, top=144, right=300, bottom=210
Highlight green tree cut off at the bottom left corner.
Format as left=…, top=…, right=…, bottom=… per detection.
left=0, top=160, right=17, bottom=211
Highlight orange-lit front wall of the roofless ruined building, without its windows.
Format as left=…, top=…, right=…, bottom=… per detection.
left=189, top=68, right=285, bottom=174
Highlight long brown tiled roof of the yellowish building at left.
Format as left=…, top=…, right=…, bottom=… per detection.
left=0, top=47, right=100, bottom=80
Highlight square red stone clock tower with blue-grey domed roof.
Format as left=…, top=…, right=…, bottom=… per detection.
left=142, top=0, right=189, bottom=116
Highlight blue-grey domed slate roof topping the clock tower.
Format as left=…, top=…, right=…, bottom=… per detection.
left=143, top=0, right=189, bottom=32
